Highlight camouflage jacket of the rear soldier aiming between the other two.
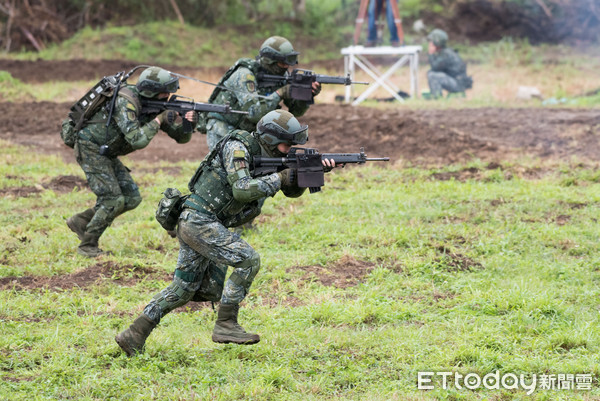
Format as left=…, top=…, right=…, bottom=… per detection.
left=208, top=59, right=308, bottom=132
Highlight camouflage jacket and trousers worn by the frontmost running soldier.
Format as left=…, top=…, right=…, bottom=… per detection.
left=144, top=139, right=281, bottom=323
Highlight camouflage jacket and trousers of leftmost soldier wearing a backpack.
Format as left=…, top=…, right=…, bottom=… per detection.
left=74, top=86, right=191, bottom=236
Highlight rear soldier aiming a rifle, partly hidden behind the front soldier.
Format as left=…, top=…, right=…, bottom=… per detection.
left=200, top=36, right=321, bottom=149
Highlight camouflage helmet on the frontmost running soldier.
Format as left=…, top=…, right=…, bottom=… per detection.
left=256, top=110, right=308, bottom=153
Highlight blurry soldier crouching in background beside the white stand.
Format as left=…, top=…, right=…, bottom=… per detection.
left=427, top=29, right=473, bottom=98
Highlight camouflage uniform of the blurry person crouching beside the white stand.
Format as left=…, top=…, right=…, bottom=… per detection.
left=427, top=48, right=467, bottom=97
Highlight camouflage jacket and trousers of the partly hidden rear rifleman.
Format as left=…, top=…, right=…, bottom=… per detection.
left=206, top=61, right=309, bottom=149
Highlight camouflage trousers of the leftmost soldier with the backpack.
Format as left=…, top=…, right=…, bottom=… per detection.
left=75, top=140, right=142, bottom=237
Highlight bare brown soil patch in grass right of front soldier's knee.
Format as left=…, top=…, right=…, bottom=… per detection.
left=287, top=256, right=375, bottom=288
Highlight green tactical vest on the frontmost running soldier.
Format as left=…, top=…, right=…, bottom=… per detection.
left=184, top=130, right=261, bottom=227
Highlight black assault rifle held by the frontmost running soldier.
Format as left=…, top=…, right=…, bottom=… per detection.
left=252, top=148, right=390, bottom=193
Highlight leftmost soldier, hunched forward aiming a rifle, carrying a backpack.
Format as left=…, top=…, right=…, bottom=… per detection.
left=67, top=67, right=198, bottom=257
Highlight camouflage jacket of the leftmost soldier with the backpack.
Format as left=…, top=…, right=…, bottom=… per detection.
left=78, top=85, right=192, bottom=157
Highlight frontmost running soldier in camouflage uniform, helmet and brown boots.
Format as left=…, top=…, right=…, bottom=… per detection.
left=115, top=110, right=335, bottom=356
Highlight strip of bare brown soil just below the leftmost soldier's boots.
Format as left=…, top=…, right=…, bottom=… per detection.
left=0, top=261, right=171, bottom=290
